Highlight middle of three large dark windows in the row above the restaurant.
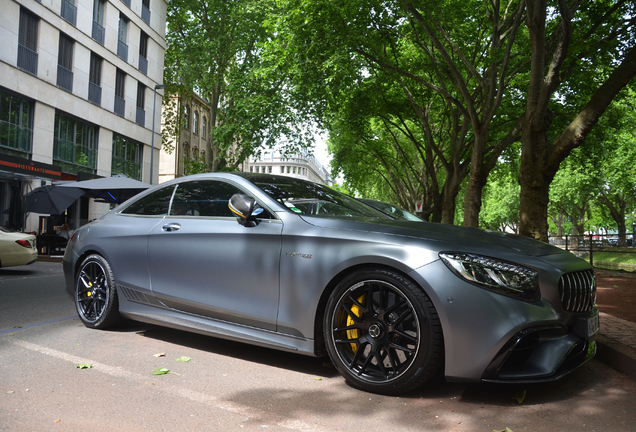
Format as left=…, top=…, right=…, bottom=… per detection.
left=53, top=111, right=97, bottom=174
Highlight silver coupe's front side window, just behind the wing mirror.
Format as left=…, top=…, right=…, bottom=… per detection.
left=170, top=180, right=243, bottom=217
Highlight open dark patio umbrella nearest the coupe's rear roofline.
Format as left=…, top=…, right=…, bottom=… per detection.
left=59, top=175, right=150, bottom=204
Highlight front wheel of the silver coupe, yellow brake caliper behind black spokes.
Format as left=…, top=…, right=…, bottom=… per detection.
left=323, top=270, right=444, bottom=395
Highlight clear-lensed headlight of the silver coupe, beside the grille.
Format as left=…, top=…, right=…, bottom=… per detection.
left=439, top=252, right=541, bottom=301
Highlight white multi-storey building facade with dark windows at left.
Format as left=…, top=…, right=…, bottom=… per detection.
left=0, top=0, right=167, bottom=231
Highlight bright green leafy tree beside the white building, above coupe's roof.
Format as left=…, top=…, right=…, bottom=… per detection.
left=165, top=0, right=308, bottom=171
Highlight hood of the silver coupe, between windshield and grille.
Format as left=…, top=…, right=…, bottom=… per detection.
left=301, top=216, right=567, bottom=256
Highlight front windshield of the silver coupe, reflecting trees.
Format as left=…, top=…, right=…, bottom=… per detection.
left=246, top=175, right=391, bottom=219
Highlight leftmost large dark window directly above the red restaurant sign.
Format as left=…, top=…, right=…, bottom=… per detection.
left=0, top=90, right=33, bottom=158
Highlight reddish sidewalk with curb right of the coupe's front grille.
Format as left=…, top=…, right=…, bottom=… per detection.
left=595, top=270, right=636, bottom=380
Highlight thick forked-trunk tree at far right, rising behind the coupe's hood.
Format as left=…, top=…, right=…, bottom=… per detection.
left=520, top=0, right=636, bottom=241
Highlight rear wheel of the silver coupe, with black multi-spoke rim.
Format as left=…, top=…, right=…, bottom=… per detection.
left=75, top=255, right=121, bottom=329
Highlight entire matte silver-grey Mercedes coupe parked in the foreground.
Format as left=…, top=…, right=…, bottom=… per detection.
left=64, top=173, right=599, bottom=395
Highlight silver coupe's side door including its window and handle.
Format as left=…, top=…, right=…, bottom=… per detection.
left=148, top=181, right=283, bottom=330
